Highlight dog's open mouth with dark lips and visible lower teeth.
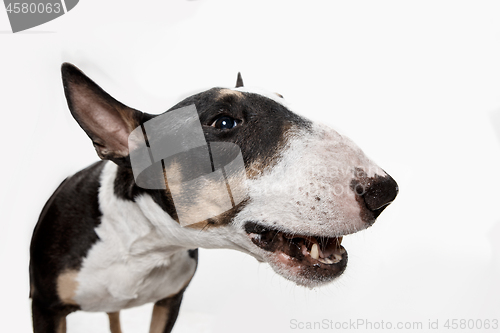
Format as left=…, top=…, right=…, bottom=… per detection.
left=244, top=222, right=347, bottom=282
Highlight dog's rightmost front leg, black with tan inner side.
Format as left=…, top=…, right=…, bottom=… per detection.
left=149, top=290, right=184, bottom=333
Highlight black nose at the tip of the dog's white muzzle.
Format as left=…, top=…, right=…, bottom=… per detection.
left=363, top=175, right=399, bottom=217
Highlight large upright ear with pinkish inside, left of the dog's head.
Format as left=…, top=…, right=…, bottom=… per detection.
left=61, top=63, right=143, bottom=162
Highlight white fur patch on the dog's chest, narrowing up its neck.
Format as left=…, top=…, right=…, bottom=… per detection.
left=74, top=162, right=196, bottom=312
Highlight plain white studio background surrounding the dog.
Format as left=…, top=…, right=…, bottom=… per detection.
left=0, top=0, right=500, bottom=333
